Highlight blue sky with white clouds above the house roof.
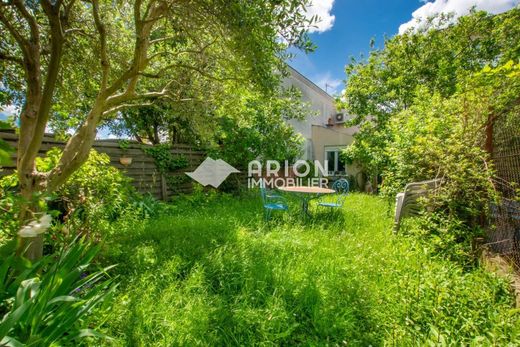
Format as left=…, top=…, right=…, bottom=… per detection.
left=289, top=0, right=519, bottom=94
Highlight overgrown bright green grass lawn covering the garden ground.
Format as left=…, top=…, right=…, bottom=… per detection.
left=91, top=194, right=520, bottom=346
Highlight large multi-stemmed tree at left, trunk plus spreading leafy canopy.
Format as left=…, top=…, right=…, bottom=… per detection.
left=0, top=0, right=313, bottom=254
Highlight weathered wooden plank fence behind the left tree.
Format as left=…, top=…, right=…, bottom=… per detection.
left=0, top=130, right=206, bottom=200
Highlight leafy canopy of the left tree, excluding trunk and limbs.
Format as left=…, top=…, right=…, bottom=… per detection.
left=0, top=0, right=317, bottom=141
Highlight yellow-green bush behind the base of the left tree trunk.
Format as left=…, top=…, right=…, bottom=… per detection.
left=0, top=148, right=162, bottom=246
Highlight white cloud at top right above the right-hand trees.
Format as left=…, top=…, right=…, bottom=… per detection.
left=399, top=0, right=520, bottom=34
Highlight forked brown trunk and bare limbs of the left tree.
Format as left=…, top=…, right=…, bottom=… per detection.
left=7, top=0, right=169, bottom=260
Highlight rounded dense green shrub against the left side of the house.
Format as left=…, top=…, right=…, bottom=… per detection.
left=210, top=90, right=311, bottom=167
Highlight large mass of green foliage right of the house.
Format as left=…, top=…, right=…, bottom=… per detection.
left=344, top=9, right=520, bottom=262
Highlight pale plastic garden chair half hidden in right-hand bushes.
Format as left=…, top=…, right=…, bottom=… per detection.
left=394, top=179, right=441, bottom=233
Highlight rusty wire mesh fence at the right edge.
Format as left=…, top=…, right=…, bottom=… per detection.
left=486, top=115, right=520, bottom=272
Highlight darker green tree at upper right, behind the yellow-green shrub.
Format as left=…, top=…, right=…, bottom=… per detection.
left=344, top=9, right=520, bottom=178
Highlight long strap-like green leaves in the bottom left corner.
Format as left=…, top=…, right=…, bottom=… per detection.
left=0, top=241, right=115, bottom=346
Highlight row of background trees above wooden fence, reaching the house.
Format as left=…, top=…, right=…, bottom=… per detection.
left=103, top=83, right=312, bottom=166
